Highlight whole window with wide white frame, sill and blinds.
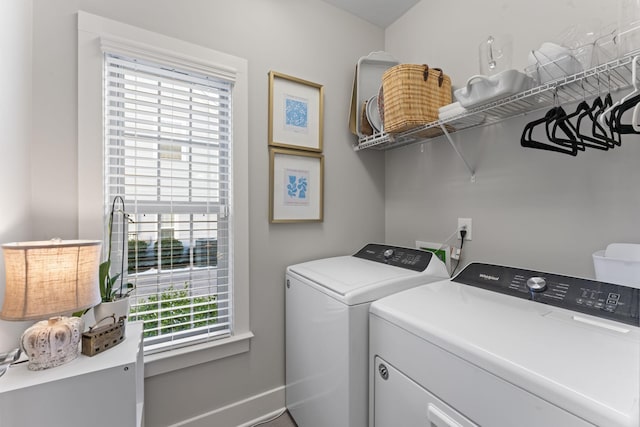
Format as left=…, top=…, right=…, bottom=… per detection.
left=78, top=11, right=253, bottom=377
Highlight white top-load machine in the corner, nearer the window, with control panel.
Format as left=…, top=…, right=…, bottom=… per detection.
left=285, top=244, right=448, bottom=427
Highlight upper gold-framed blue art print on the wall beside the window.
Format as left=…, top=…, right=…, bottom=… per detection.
left=269, top=71, right=324, bottom=152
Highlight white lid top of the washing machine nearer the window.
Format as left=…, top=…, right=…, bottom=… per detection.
left=287, top=251, right=448, bottom=305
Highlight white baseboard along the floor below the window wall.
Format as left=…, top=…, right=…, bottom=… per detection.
left=171, top=386, right=285, bottom=427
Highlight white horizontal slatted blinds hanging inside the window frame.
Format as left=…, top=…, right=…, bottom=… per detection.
left=104, top=52, right=233, bottom=354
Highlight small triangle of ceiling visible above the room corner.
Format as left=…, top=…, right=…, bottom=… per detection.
left=324, top=0, right=420, bottom=28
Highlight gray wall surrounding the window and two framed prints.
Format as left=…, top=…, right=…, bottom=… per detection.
left=31, top=0, right=384, bottom=426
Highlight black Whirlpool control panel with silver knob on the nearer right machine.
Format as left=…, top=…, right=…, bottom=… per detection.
left=452, top=263, right=640, bottom=326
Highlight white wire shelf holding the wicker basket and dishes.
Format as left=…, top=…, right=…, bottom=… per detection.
left=354, top=50, right=640, bottom=151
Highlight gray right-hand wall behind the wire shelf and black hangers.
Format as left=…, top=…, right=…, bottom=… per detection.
left=385, top=0, right=640, bottom=277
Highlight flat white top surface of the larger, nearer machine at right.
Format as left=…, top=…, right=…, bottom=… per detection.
left=370, top=280, right=640, bottom=427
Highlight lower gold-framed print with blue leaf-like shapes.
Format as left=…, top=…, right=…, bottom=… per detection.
left=269, top=148, right=324, bottom=223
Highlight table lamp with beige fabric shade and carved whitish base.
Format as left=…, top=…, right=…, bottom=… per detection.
left=0, top=239, right=102, bottom=371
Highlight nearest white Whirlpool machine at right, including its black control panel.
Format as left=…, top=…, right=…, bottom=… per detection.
left=370, top=263, right=640, bottom=427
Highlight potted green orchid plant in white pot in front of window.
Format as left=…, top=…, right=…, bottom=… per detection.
left=93, top=196, right=134, bottom=322
